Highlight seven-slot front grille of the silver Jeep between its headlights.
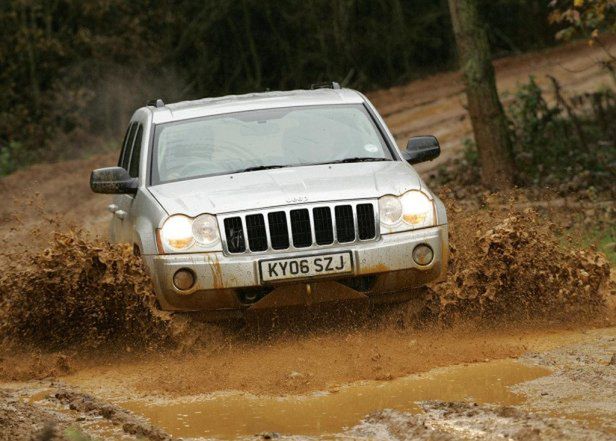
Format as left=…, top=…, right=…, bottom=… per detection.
left=222, top=202, right=377, bottom=254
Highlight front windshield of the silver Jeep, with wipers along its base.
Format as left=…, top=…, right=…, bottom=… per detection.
left=152, top=104, right=392, bottom=185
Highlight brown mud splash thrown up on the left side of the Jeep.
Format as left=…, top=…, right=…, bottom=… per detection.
left=0, top=232, right=173, bottom=349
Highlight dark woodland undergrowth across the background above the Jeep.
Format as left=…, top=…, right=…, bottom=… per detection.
left=0, top=0, right=553, bottom=175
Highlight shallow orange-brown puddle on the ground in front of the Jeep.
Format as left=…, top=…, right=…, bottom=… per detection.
left=120, top=360, right=550, bottom=439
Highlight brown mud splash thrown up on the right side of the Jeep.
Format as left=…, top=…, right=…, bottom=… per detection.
left=424, top=203, right=613, bottom=323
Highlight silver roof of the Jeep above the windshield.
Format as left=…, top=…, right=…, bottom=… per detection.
left=149, top=89, right=364, bottom=124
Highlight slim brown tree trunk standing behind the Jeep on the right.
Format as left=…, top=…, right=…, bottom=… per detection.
left=449, top=0, right=514, bottom=190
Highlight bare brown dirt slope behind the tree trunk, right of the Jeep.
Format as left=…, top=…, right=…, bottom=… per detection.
left=368, top=38, right=616, bottom=174
